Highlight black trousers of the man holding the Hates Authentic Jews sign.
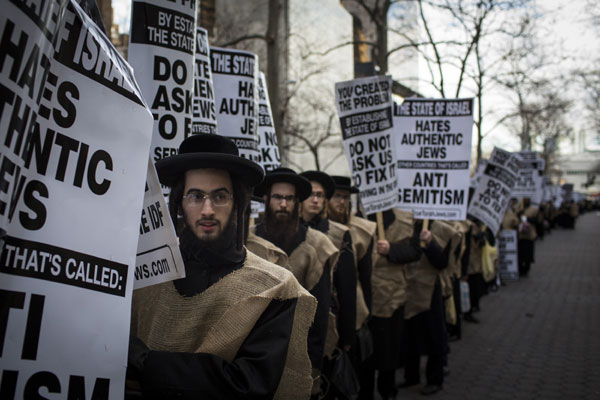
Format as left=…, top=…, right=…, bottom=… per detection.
left=404, top=280, right=448, bottom=386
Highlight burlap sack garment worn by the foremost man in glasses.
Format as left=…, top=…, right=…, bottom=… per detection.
left=131, top=251, right=316, bottom=400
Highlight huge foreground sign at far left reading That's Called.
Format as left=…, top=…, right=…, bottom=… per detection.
left=0, top=0, right=152, bottom=400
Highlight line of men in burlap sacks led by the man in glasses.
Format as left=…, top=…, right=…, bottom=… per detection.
left=126, top=134, right=508, bottom=399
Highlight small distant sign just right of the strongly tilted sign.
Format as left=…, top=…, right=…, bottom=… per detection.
left=512, top=151, right=544, bottom=205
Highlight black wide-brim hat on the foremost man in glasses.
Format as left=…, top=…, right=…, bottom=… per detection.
left=156, top=134, right=265, bottom=187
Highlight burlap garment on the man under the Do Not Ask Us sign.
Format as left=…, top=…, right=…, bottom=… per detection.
left=371, top=209, right=413, bottom=318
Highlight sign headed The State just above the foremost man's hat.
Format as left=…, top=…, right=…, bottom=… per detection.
left=210, top=47, right=259, bottom=162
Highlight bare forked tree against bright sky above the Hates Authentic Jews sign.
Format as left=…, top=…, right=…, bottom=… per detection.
left=388, top=0, right=531, bottom=161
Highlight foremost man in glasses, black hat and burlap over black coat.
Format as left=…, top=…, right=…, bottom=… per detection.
left=128, top=134, right=316, bottom=399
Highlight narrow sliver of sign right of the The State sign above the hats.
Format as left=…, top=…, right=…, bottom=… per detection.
left=258, top=72, right=281, bottom=172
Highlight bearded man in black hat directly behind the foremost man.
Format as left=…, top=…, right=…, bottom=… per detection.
left=255, top=168, right=338, bottom=394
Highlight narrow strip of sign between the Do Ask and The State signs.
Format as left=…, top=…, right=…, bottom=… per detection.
left=192, top=27, right=217, bottom=133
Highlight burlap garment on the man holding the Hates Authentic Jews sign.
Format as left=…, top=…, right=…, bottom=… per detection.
left=404, top=221, right=456, bottom=319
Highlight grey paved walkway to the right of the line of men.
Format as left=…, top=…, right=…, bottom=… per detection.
left=384, top=212, right=600, bottom=400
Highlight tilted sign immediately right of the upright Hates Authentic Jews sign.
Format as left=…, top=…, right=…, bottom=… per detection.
left=468, top=147, right=519, bottom=234
